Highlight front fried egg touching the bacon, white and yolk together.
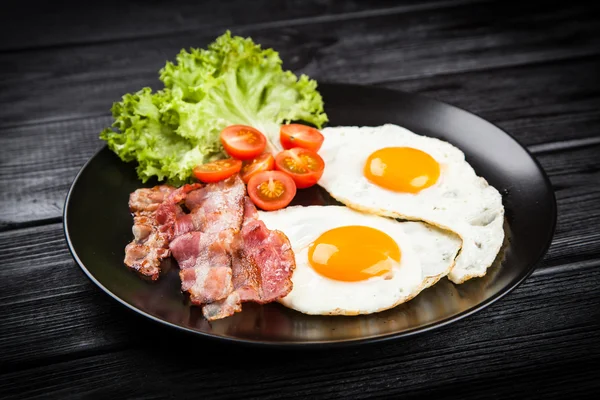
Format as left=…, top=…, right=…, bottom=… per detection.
left=259, top=206, right=461, bottom=315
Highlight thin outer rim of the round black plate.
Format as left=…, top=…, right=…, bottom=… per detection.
left=62, top=82, right=557, bottom=349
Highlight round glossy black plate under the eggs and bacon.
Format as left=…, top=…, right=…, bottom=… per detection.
left=64, top=84, right=556, bottom=346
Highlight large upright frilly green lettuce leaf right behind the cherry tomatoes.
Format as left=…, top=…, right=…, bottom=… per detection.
left=160, top=31, right=327, bottom=150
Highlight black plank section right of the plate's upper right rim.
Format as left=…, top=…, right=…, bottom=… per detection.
left=379, top=57, right=600, bottom=147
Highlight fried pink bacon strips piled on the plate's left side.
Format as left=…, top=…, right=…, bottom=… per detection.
left=125, top=175, right=295, bottom=320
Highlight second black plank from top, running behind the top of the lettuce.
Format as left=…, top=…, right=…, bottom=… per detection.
left=0, top=1, right=600, bottom=126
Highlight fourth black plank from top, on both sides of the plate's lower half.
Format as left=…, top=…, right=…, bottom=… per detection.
left=0, top=146, right=600, bottom=369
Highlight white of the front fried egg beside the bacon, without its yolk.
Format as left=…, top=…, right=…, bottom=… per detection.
left=259, top=206, right=461, bottom=315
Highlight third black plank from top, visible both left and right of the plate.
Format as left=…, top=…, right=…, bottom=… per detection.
left=0, top=58, right=600, bottom=229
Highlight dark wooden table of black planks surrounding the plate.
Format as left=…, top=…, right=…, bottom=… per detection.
left=0, top=0, right=600, bottom=399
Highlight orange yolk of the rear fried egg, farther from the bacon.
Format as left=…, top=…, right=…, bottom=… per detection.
left=364, top=147, right=440, bottom=193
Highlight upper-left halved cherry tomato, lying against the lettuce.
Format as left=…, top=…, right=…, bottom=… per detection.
left=220, top=125, right=267, bottom=160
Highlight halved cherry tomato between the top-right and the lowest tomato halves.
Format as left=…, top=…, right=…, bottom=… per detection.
left=275, top=147, right=325, bottom=189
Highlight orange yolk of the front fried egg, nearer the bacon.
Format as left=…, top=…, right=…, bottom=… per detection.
left=308, top=225, right=400, bottom=282
